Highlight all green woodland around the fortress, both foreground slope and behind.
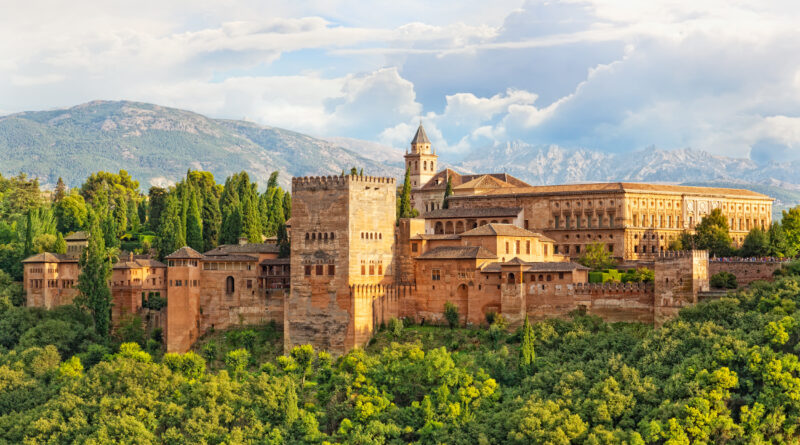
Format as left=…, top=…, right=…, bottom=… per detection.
left=0, top=171, right=800, bottom=444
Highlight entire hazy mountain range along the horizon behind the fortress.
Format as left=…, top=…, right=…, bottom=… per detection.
left=0, top=101, right=800, bottom=210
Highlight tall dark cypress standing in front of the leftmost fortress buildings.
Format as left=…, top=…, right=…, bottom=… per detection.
left=77, top=214, right=111, bottom=339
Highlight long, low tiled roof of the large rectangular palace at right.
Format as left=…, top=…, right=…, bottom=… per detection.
left=449, top=182, right=772, bottom=199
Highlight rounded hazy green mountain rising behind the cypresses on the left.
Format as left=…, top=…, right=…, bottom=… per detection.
left=0, top=101, right=402, bottom=188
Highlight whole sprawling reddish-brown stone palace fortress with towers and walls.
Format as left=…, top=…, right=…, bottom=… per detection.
left=24, top=125, right=778, bottom=353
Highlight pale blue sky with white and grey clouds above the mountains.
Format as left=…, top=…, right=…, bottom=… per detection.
left=0, top=0, right=800, bottom=162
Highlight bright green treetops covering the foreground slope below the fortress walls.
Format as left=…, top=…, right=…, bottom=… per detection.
left=0, top=267, right=800, bottom=444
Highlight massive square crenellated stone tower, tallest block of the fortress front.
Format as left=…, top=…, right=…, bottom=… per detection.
left=284, top=175, right=397, bottom=354
